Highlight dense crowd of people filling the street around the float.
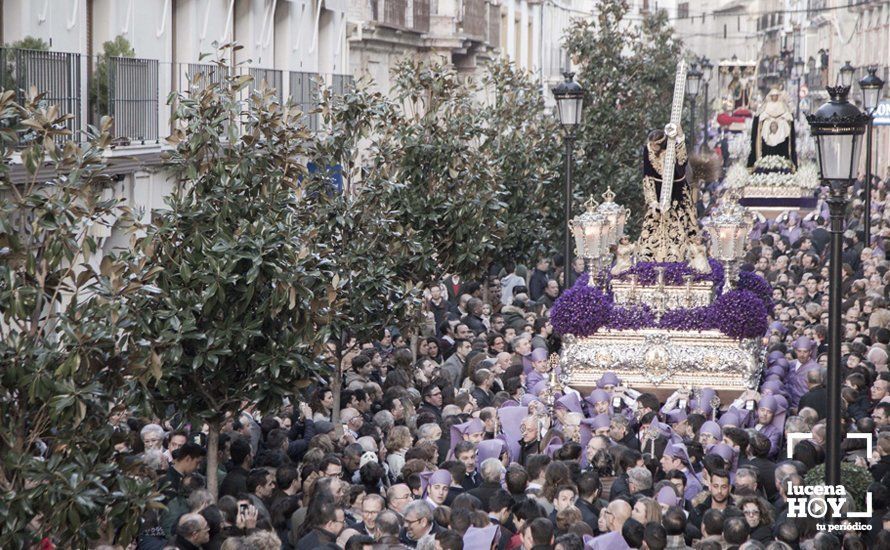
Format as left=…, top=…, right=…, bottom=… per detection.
left=119, top=174, right=890, bottom=550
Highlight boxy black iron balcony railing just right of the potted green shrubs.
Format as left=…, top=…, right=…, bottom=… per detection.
left=107, top=57, right=159, bottom=143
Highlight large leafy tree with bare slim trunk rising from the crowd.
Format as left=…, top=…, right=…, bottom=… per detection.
left=139, top=54, right=340, bottom=493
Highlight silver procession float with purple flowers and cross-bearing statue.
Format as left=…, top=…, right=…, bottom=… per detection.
left=551, top=62, right=773, bottom=398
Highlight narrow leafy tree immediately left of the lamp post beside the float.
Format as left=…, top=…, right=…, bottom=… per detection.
left=482, top=61, right=563, bottom=262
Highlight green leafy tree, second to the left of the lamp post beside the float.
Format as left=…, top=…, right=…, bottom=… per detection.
left=380, top=61, right=506, bottom=282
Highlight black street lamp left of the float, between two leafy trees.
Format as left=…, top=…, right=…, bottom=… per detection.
left=552, top=71, right=592, bottom=288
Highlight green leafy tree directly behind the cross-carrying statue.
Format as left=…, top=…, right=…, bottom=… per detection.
left=560, top=0, right=682, bottom=235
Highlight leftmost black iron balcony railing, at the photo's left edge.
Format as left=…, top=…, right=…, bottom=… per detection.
left=0, top=48, right=83, bottom=140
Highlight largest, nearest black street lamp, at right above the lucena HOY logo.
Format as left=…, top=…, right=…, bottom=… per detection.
left=807, top=86, right=869, bottom=492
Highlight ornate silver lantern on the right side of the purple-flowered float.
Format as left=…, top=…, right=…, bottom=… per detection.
left=702, top=196, right=753, bottom=292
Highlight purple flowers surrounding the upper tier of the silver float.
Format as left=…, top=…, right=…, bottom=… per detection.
left=550, top=266, right=773, bottom=339
